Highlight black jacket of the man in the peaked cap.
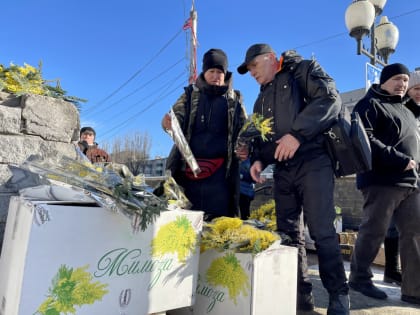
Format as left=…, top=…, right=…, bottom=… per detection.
left=252, top=51, right=341, bottom=166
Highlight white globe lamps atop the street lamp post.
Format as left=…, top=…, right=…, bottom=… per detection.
left=345, top=0, right=399, bottom=66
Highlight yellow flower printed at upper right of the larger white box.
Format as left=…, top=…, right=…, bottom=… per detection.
left=151, top=215, right=197, bottom=263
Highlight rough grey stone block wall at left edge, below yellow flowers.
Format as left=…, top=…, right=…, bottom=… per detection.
left=0, top=92, right=80, bottom=248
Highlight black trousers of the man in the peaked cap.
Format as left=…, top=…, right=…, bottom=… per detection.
left=273, top=154, right=348, bottom=294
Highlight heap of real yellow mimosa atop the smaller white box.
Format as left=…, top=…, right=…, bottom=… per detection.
left=201, top=217, right=279, bottom=253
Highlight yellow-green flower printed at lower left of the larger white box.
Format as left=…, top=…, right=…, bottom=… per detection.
left=35, top=265, right=108, bottom=315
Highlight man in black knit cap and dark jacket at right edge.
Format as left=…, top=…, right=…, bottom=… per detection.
left=349, top=63, right=420, bottom=304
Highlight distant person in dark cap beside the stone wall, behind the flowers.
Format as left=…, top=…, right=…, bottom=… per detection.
left=78, top=127, right=111, bottom=163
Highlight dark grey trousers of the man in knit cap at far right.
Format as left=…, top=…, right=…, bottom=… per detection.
left=350, top=186, right=420, bottom=297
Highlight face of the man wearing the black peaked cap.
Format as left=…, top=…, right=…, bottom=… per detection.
left=247, top=53, right=277, bottom=84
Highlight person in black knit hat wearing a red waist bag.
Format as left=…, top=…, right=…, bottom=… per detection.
left=162, top=49, right=246, bottom=221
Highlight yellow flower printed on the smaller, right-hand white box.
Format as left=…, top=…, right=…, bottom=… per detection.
left=206, top=253, right=251, bottom=304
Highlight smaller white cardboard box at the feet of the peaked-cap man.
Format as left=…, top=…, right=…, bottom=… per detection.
left=168, top=242, right=297, bottom=315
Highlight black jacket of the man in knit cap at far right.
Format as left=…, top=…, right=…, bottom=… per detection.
left=354, top=84, right=420, bottom=188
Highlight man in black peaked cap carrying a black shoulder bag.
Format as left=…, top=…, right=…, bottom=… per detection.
left=238, top=44, right=349, bottom=315
